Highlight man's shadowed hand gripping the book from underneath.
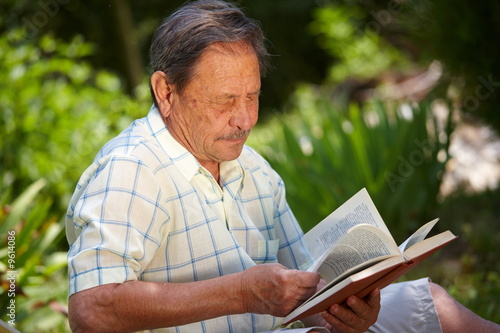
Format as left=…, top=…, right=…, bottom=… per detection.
left=321, top=289, right=380, bottom=333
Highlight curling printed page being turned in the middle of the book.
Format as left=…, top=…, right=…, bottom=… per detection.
left=317, top=224, right=401, bottom=282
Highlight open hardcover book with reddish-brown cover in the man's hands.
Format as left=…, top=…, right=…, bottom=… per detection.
left=284, top=189, right=457, bottom=324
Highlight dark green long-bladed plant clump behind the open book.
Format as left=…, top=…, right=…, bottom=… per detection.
left=250, top=86, right=449, bottom=236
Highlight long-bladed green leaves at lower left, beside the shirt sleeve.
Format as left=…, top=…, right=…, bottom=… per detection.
left=0, top=179, right=67, bottom=332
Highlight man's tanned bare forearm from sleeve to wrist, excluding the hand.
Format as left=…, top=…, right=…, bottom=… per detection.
left=69, top=274, right=244, bottom=332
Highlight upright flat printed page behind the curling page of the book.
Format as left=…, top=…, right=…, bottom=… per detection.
left=304, top=188, right=390, bottom=259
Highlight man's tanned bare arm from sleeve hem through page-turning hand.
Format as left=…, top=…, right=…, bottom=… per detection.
left=69, top=264, right=319, bottom=333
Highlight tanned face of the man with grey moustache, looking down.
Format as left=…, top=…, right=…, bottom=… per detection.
left=166, top=43, right=260, bottom=167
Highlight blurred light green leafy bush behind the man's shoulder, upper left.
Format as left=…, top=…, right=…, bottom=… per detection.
left=0, top=30, right=147, bottom=209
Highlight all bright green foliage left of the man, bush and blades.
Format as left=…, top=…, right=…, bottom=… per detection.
left=0, top=30, right=149, bottom=332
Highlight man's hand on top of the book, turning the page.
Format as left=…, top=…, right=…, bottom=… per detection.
left=240, top=264, right=319, bottom=317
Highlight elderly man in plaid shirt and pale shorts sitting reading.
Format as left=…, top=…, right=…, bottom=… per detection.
left=66, top=1, right=500, bottom=333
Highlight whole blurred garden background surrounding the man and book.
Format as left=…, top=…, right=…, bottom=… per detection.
left=0, top=0, right=500, bottom=332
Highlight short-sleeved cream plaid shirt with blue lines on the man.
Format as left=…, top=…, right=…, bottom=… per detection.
left=66, top=107, right=309, bottom=332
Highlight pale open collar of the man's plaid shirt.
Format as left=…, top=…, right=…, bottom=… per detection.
left=146, top=105, right=245, bottom=181
